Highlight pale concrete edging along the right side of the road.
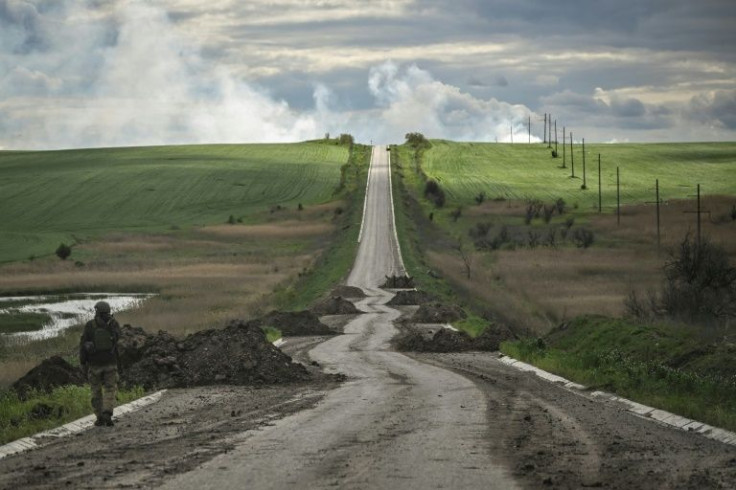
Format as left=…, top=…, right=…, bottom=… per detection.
left=499, top=355, right=736, bottom=446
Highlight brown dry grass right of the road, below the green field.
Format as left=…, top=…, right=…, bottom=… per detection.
left=427, top=196, right=736, bottom=334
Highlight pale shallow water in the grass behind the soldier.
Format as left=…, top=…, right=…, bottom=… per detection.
left=0, top=293, right=154, bottom=340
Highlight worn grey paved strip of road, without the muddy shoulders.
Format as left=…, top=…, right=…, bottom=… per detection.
left=163, top=146, right=515, bottom=490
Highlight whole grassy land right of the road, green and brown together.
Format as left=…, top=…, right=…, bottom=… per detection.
left=392, top=141, right=736, bottom=430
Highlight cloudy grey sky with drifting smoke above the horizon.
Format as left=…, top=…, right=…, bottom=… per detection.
left=0, top=0, right=736, bottom=149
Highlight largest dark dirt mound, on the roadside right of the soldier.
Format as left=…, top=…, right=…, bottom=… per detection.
left=120, top=321, right=309, bottom=390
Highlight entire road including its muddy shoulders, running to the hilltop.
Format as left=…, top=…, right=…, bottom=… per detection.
left=0, top=147, right=736, bottom=490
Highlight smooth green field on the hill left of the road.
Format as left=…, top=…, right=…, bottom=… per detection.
left=0, top=141, right=348, bottom=262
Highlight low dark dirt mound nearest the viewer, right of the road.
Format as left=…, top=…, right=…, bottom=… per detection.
left=394, top=325, right=517, bottom=352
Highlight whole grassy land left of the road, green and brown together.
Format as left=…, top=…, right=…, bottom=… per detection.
left=0, top=140, right=370, bottom=387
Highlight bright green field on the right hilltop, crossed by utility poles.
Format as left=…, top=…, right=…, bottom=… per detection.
left=422, top=140, right=736, bottom=210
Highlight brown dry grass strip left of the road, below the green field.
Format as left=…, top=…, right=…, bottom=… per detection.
left=0, top=218, right=334, bottom=386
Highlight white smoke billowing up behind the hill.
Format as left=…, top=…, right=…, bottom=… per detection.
left=0, top=0, right=530, bottom=149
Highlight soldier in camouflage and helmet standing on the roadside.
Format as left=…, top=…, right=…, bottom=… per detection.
left=79, top=301, right=120, bottom=427
